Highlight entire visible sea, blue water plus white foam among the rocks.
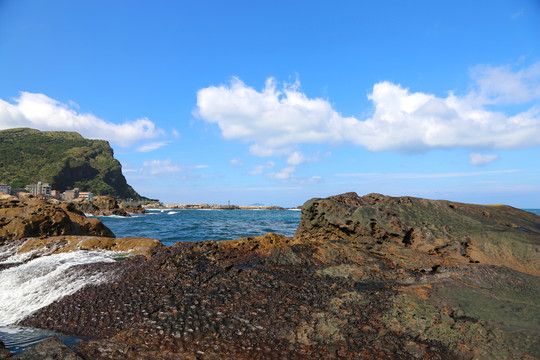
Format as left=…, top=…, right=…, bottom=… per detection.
left=0, top=209, right=540, bottom=354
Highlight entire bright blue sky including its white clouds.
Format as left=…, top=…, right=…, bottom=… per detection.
left=0, top=0, right=540, bottom=208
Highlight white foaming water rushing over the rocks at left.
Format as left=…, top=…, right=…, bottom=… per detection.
left=0, top=251, right=116, bottom=326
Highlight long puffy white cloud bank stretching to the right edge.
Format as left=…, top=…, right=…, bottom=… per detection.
left=195, top=62, right=540, bottom=155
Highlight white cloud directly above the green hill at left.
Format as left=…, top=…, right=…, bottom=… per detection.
left=0, top=92, right=164, bottom=147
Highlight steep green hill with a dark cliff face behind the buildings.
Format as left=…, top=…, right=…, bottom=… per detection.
left=0, top=128, right=141, bottom=200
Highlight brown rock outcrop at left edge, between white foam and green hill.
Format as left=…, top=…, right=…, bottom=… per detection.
left=0, top=199, right=114, bottom=245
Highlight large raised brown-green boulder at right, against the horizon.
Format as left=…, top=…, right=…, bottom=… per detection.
left=295, top=193, right=540, bottom=276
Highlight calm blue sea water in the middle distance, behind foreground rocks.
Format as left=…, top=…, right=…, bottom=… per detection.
left=95, top=209, right=301, bottom=245
